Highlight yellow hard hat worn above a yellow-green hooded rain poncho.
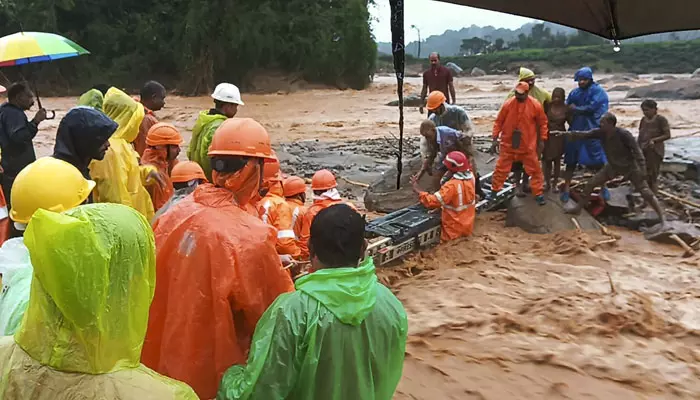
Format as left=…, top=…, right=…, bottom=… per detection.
left=10, top=157, right=95, bottom=224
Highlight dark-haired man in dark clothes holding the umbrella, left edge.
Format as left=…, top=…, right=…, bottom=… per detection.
left=0, top=83, right=46, bottom=236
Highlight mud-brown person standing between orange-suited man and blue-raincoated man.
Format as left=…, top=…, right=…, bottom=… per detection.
left=542, top=88, right=571, bottom=193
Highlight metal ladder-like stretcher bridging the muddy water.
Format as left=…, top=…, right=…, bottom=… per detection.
left=365, top=173, right=515, bottom=266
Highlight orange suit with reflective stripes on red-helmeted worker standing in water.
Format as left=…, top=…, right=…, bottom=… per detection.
left=420, top=172, right=476, bottom=242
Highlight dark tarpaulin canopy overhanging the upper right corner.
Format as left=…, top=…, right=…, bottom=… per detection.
left=437, top=0, right=700, bottom=40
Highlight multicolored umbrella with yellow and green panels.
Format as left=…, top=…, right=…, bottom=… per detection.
left=0, top=32, right=90, bottom=67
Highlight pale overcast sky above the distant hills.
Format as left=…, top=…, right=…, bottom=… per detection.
left=370, top=0, right=532, bottom=44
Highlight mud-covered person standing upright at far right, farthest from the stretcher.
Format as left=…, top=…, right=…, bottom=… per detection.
left=637, top=100, right=671, bottom=194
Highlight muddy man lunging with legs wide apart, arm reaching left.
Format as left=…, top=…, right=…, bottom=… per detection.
left=555, top=113, right=666, bottom=228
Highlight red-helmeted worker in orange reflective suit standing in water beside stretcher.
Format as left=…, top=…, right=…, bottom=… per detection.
left=411, top=151, right=476, bottom=242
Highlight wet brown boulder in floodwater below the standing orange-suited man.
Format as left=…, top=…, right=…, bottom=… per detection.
left=506, top=193, right=598, bottom=234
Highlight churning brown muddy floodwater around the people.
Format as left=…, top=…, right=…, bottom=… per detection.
left=35, top=76, right=700, bottom=400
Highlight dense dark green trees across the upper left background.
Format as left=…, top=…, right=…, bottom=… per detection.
left=0, top=0, right=377, bottom=93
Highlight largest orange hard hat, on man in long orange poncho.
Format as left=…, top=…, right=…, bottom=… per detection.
left=208, top=118, right=275, bottom=159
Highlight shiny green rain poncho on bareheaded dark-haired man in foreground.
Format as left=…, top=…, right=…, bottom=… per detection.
left=217, top=258, right=408, bottom=400
